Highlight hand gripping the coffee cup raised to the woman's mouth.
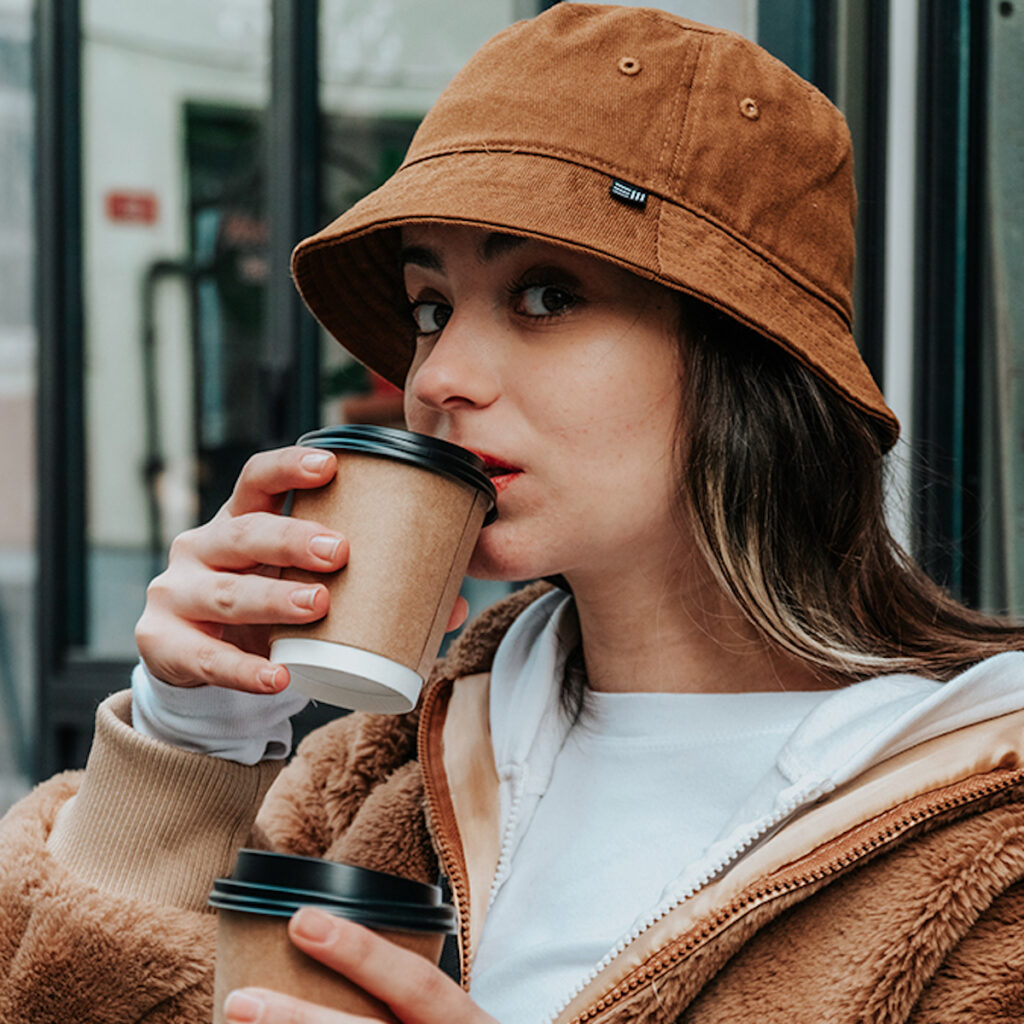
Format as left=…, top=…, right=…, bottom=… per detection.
left=135, top=447, right=348, bottom=693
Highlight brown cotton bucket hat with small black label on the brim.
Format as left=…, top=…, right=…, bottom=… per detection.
left=292, top=3, right=899, bottom=444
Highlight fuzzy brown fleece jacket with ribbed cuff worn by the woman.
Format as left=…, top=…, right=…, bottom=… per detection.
left=0, top=595, right=1024, bottom=1024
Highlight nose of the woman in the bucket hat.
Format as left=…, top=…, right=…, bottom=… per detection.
left=406, top=311, right=500, bottom=413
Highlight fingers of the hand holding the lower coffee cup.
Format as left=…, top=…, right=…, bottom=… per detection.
left=224, top=907, right=496, bottom=1024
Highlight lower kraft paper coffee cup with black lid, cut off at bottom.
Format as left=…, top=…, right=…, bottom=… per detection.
left=210, top=850, right=457, bottom=1024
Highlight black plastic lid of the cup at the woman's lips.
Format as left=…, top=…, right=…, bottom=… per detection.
left=296, top=423, right=498, bottom=526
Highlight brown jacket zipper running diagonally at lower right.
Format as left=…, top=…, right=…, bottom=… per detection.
left=553, top=769, right=1024, bottom=1024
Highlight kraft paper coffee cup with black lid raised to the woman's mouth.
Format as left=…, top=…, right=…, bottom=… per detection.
left=270, top=425, right=497, bottom=714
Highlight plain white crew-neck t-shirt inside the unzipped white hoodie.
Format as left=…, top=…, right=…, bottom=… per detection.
left=472, top=679, right=828, bottom=1022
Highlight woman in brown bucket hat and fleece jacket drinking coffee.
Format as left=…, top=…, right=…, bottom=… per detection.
left=0, top=4, right=1024, bottom=1024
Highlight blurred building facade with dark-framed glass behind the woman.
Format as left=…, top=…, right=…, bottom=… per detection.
left=0, top=0, right=1024, bottom=790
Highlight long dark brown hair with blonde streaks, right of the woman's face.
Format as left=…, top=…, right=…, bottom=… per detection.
left=678, top=297, right=1024, bottom=680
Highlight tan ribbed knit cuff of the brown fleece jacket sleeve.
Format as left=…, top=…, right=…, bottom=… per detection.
left=47, top=692, right=283, bottom=910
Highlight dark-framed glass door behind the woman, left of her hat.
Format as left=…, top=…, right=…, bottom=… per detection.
left=37, top=0, right=538, bottom=775
